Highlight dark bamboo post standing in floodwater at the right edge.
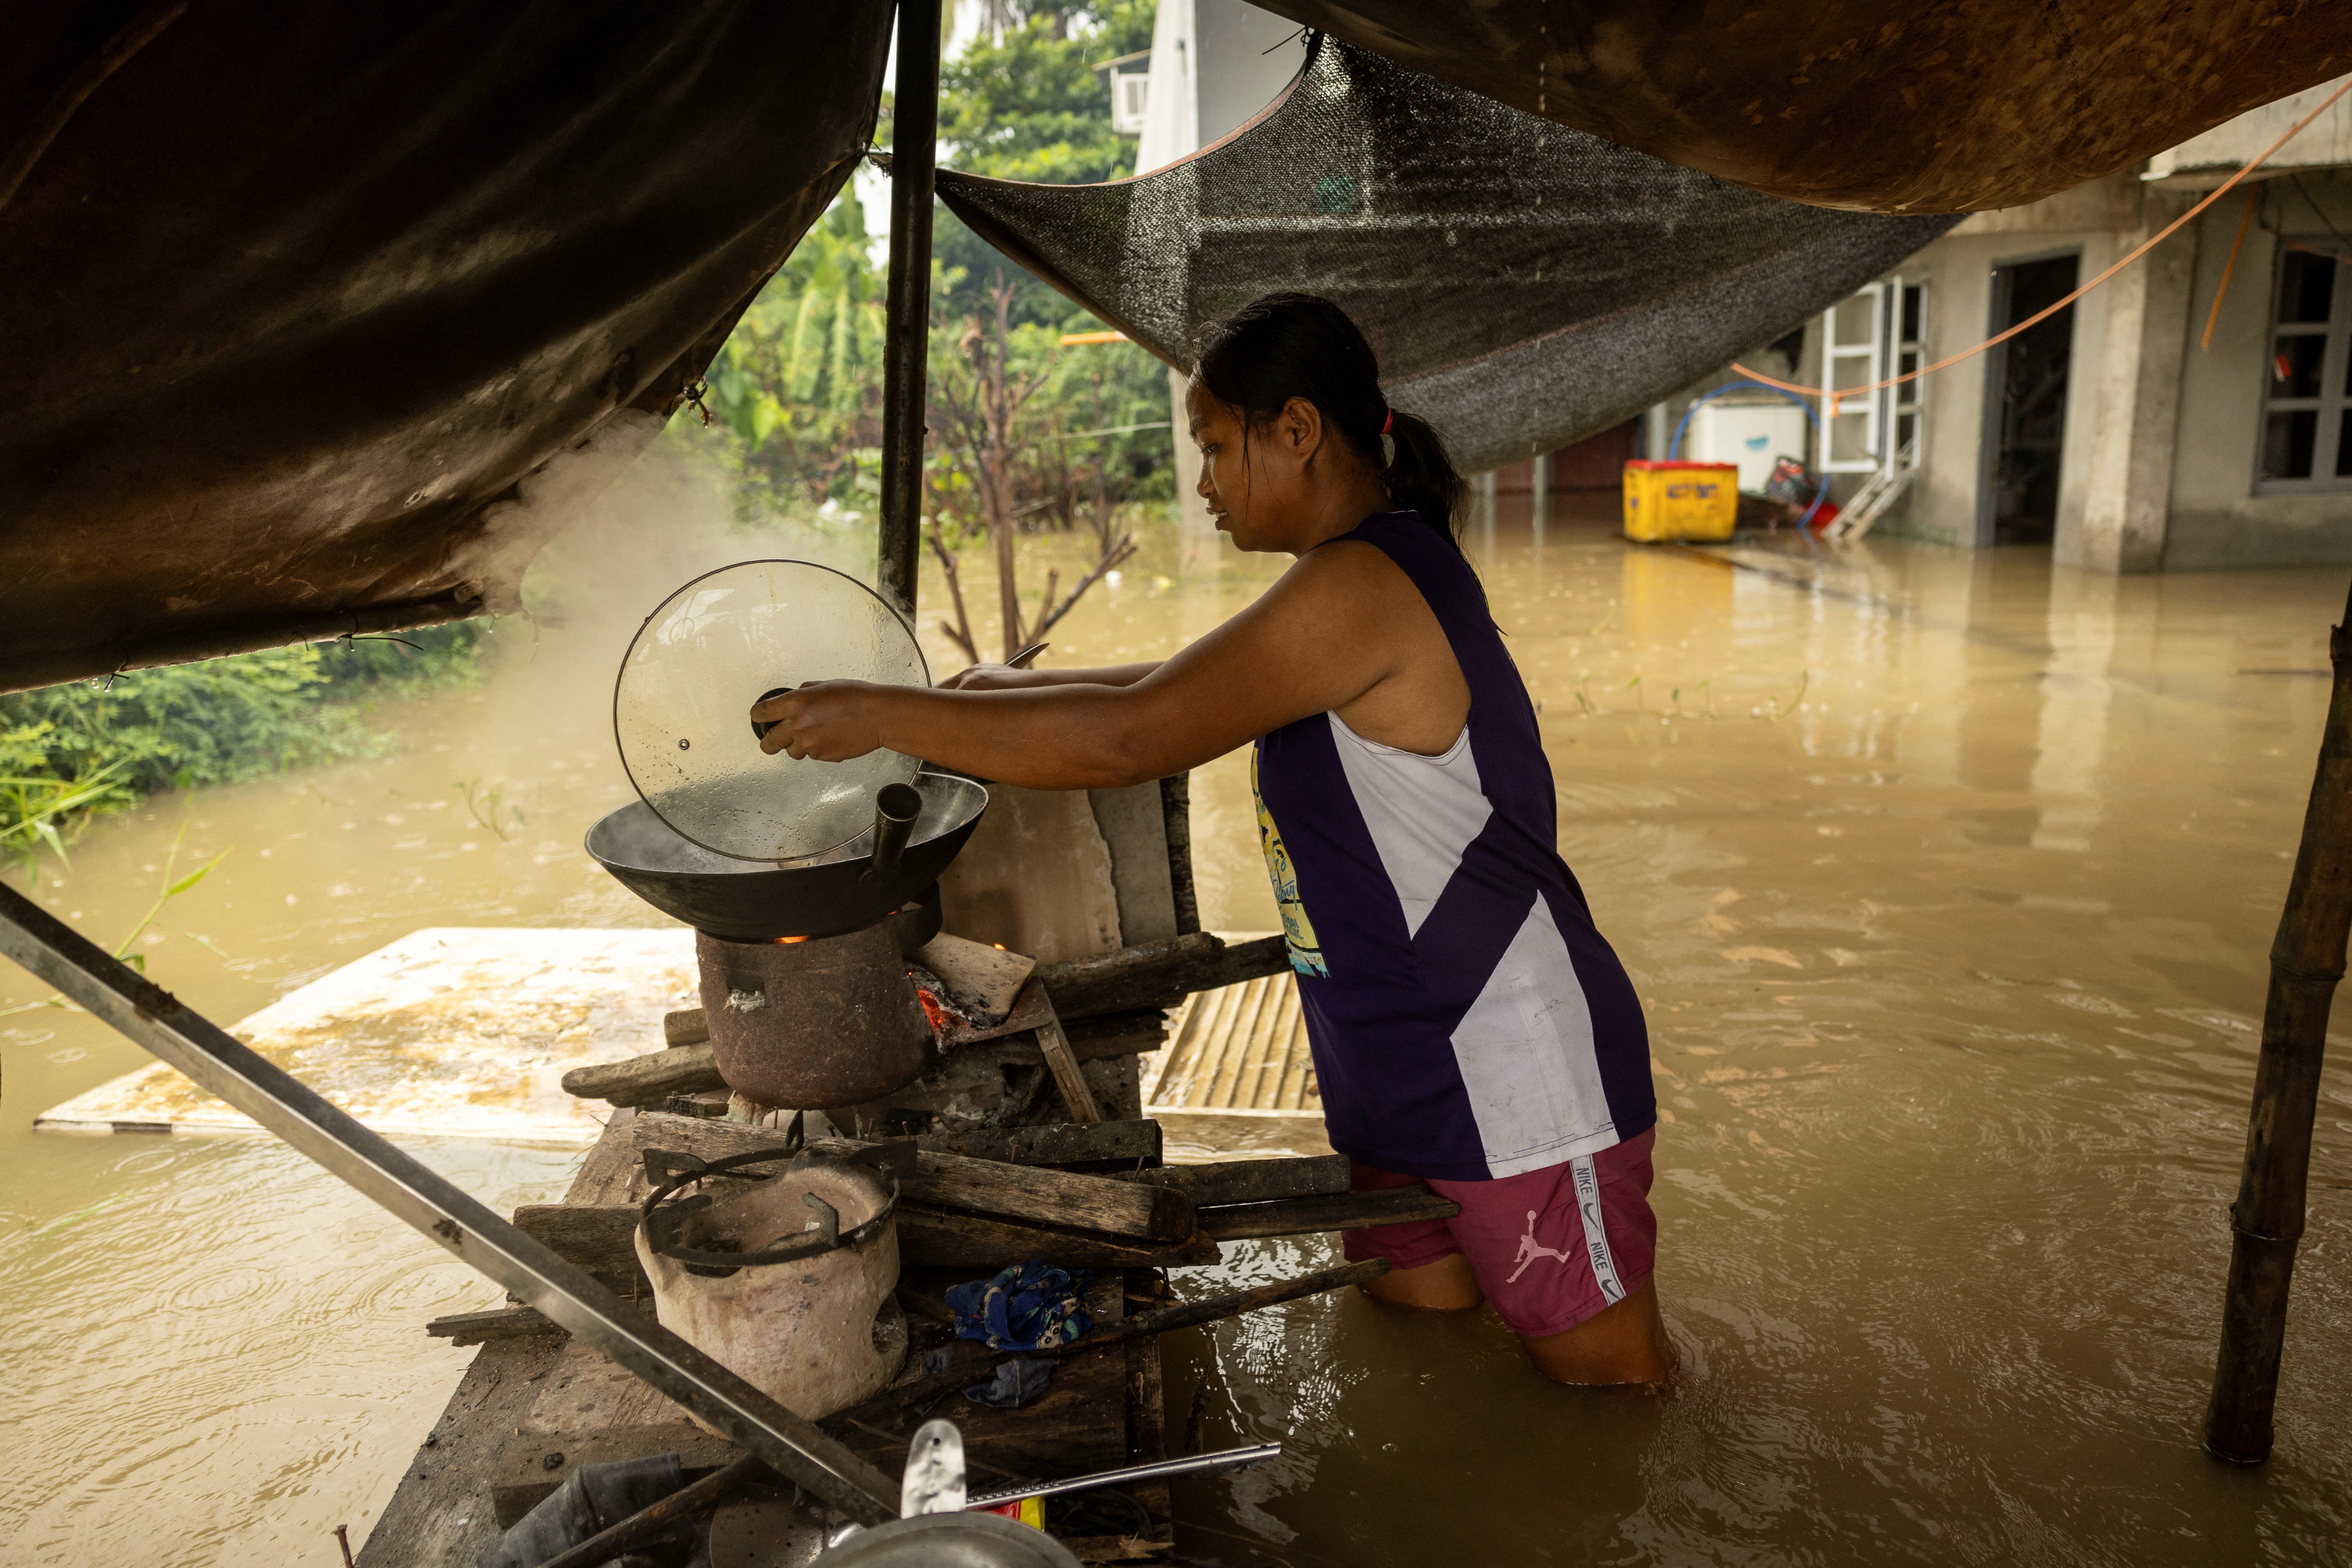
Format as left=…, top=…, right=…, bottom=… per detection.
left=2204, top=583, right=2352, bottom=1465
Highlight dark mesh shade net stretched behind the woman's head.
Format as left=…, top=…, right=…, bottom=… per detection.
left=938, top=38, right=1959, bottom=473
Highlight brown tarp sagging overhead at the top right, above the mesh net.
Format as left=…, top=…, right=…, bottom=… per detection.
left=1254, top=0, right=2352, bottom=212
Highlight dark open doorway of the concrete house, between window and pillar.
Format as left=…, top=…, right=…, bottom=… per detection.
left=1976, top=256, right=2079, bottom=545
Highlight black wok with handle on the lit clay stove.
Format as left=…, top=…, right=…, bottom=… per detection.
left=588, top=773, right=988, bottom=943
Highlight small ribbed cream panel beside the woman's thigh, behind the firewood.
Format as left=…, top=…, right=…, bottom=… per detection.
left=1148, top=973, right=1322, bottom=1117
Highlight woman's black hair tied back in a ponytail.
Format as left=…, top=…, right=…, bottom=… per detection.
left=1193, top=294, right=1463, bottom=553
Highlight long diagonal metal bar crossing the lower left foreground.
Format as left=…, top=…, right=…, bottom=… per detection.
left=0, top=884, right=898, bottom=1523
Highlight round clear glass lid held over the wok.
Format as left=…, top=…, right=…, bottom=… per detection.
left=611, top=562, right=931, bottom=860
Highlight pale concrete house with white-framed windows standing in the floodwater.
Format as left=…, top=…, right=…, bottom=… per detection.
left=1759, top=85, right=2352, bottom=571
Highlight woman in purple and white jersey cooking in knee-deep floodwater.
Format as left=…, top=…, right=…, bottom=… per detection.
left=753, top=294, right=1672, bottom=1385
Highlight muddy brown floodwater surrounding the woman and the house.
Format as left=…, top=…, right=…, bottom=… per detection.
left=0, top=465, right=2352, bottom=1565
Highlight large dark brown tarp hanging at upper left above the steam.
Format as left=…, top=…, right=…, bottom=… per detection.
left=0, top=0, right=891, bottom=689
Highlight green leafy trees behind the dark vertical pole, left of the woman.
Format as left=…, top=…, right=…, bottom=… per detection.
left=687, top=0, right=1169, bottom=656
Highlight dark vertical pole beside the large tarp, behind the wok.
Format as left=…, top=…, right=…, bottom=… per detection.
left=875, top=0, right=938, bottom=620
